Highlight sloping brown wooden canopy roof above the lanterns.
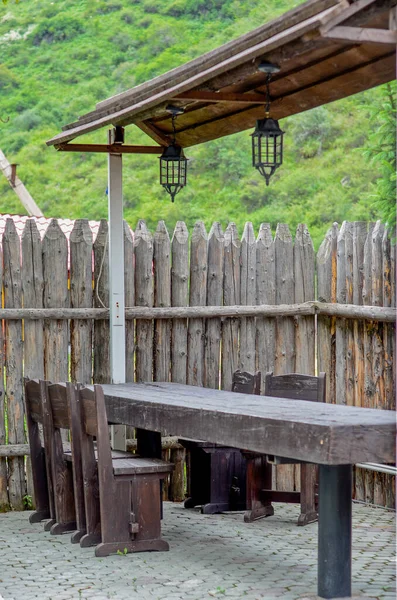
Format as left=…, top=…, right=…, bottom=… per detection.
left=47, top=0, right=397, bottom=151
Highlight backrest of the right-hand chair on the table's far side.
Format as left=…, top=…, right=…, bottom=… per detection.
left=265, top=373, right=326, bottom=402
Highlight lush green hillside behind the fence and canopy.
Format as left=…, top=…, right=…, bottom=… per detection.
left=0, top=0, right=394, bottom=245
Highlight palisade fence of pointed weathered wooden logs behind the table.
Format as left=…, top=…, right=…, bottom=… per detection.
left=0, top=219, right=395, bottom=510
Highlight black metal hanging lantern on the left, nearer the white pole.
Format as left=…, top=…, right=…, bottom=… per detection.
left=160, top=106, right=187, bottom=202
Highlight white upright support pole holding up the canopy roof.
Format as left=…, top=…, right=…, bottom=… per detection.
left=108, top=131, right=126, bottom=450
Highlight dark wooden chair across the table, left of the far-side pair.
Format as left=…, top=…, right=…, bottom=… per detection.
left=180, top=371, right=260, bottom=514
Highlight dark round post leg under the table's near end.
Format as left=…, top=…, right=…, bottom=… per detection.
left=318, top=465, right=352, bottom=598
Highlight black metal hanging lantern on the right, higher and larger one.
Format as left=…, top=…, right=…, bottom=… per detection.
left=251, top=63, right=284, bottom=185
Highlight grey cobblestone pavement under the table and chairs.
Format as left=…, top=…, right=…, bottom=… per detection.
left=0, top=503, right=396, bottom=600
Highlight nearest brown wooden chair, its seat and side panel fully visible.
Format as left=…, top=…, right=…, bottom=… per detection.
left=74, top=385, right=173, bottom=556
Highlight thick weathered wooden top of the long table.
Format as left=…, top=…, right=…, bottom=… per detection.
left=102, top=382, right=396, bottom=465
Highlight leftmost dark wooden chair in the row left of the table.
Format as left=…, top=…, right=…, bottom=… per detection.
left=24, top=377, right=55, bottom=527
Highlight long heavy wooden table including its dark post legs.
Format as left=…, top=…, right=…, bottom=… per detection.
left=103, top=383, right=396, bottom=598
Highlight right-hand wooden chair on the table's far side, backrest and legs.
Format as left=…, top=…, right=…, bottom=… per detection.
left=258, top=373, right=326, bottom=525
